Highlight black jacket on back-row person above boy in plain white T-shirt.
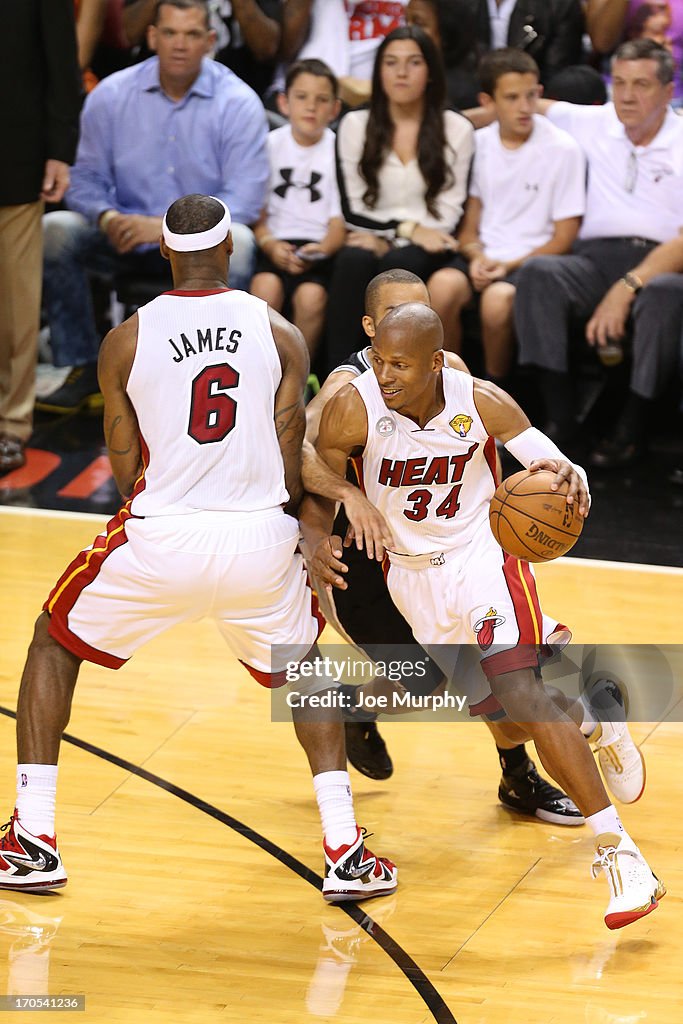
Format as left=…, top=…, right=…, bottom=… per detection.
left=470, top=0, right=584, bottom=83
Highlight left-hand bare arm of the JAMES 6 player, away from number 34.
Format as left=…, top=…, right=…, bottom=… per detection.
left=97, top=313, right=143, bottom=498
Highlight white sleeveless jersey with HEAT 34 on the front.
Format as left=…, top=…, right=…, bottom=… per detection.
left=351, top=368, right=496, bottom=555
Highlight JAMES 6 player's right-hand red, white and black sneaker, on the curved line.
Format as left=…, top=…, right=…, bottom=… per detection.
left=323, top=825, right=398, bottom=903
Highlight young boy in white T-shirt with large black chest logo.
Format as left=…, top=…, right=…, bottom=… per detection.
left=250, top=59, right=346, bottom=354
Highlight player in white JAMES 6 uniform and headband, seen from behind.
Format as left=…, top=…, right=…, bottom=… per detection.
left=0, top=195, right=396, bottom=901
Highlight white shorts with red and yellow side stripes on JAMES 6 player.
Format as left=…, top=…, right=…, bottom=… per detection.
left=43, top=507, right=324, bottom=686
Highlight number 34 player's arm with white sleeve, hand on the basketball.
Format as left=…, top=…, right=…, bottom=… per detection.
left=474, top=379, right=591, bottom=516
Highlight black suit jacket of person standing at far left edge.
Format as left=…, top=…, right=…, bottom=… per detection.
left=0, top=0, right=81, bottom=206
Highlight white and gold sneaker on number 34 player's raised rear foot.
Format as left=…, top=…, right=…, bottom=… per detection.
left=589, top=679, right=645, bottom=804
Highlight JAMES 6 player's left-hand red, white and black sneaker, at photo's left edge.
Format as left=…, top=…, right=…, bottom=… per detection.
left=0, top=808, right=67, bottom=893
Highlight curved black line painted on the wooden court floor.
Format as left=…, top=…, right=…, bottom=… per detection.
left=0, top=706, right=458, bottom=1024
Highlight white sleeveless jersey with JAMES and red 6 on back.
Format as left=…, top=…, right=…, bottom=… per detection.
left=126, top=289, right=288, bottom=516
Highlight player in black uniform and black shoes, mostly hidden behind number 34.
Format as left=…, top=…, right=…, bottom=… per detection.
left=303, top=269, right=589, bottom=825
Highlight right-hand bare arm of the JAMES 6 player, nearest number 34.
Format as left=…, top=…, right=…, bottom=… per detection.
left=268, top=309, right=309, bottom=515
